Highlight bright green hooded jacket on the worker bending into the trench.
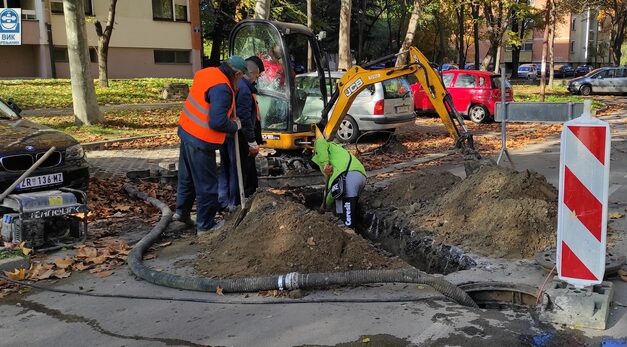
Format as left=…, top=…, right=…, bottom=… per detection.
left=311, top=138, right=366, bottom=205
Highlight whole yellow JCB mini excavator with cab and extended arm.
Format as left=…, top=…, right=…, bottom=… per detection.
left=229, top=20, right=480, bottom=186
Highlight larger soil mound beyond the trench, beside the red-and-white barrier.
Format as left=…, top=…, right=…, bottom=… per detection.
left=367, top=166, right=557, bottom=258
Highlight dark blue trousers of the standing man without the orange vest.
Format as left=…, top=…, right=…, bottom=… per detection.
left=218, top=135, right=239, bottom=209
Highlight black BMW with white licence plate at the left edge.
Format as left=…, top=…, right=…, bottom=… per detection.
left=0, top=100, right=89, bottom=196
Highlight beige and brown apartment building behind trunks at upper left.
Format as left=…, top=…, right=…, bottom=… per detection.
left=0, top=0, right=202, bottom=78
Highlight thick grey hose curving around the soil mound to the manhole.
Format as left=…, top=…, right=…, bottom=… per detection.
left=124, top=184, right=478, bottom=307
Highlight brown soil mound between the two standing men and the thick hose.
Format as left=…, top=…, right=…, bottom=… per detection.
left=194, top=192, right=407, bottom=278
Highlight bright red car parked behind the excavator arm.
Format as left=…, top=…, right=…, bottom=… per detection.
left=411, top=70, right=514, bottom=123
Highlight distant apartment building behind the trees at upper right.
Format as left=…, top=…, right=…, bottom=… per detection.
left=467, top=0, right=610, bottom=66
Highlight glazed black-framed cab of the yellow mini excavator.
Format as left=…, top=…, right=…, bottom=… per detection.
left=229, top=20, right=330, bottom=150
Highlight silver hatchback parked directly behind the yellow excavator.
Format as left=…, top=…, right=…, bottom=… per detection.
left=295, top=71, right=416, bottom=142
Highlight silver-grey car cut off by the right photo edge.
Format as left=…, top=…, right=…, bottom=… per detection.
left=568, top=66, right=627, bottom=95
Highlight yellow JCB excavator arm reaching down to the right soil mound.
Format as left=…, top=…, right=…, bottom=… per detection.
left=316, top=47, right=480, bottom=159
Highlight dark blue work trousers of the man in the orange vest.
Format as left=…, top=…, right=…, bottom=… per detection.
left=176, top=141, right=220, bottom=230
